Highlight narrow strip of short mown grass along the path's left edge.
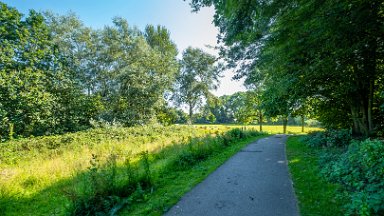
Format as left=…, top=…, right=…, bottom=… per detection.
left=120, top=135, right=267, bottom=215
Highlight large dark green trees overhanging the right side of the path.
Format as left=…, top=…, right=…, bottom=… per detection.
left=191, top=0, right=384, bottom=136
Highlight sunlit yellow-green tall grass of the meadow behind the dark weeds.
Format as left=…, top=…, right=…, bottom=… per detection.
left=0, top=125, right=264, bottom=215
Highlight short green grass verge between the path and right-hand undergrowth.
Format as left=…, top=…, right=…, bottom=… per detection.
left=287, top=136, right=346, bottom=216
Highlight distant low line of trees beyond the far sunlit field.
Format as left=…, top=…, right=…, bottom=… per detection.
left=190, top=90, right=320, bottom=128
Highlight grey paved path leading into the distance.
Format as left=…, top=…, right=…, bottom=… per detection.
left=165, top=135, right=299, bottom=216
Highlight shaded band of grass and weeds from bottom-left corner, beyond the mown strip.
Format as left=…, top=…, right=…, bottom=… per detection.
left=0, top=129, right=261, bottom=215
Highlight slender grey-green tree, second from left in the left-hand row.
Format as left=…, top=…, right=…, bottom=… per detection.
left=45, top=12, right=101, bottom=133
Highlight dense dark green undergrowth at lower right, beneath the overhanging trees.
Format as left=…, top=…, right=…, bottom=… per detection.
left=303, top=131, right=384, bottom=215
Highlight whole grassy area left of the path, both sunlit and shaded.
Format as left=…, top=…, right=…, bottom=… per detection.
left=0, top=126, right=264, bottom=215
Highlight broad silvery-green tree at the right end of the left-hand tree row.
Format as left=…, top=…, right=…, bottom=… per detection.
left=98, top=17, right=178, bottom=126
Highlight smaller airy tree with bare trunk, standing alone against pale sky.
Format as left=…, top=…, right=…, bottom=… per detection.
left=175, top=47, right=220, bottom=123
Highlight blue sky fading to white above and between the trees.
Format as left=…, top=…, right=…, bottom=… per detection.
left=0, top=0, right=244, bottom=96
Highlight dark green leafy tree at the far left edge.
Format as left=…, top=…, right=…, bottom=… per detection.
left=0, top=3, right=53, bottom=135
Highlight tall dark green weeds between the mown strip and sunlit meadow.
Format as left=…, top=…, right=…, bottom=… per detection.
left=66, top=128, right=262, bottom=215
